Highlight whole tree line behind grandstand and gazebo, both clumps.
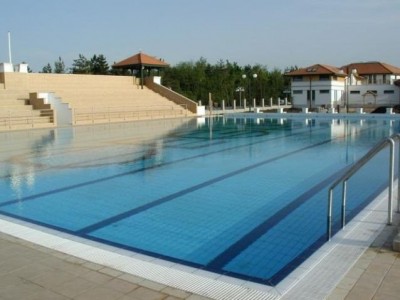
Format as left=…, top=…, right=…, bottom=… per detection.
left=42, top=54, right=297, bottom=106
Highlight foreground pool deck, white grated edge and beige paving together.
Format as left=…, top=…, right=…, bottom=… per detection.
left=0, top=189, right=400, bottom=300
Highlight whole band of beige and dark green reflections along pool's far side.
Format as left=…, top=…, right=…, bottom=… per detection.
left=0, top=117, right=398, bottom=199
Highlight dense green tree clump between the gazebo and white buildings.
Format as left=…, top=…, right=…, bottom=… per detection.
left=162, top=58, right=297, bottom=106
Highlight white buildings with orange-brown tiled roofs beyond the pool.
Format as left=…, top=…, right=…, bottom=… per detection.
left=286, top=62, right=400, bottom=109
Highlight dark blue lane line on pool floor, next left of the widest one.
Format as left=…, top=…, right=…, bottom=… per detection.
left=77, top=139, right=332, bottom=235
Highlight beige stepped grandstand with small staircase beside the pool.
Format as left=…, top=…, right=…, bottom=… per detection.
left=0, top=72, right=197, bottom=130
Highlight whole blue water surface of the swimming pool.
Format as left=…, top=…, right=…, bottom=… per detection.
left=0, top=118, right=399, bottom=285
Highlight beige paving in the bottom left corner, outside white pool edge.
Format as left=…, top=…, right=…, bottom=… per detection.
left=0, top=233, right=212, bottom=300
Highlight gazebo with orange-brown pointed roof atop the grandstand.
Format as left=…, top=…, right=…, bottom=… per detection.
left=112, top=52, right=169, bottom=89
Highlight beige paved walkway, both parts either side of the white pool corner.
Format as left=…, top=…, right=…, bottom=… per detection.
left=0, top=227, right=400, bottom=300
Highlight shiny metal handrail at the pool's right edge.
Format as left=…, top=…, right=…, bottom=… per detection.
left=327, top=134, right=400, bottom=240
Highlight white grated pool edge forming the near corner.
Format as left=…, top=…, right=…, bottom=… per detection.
left=0, top=190, right=394, bottom=300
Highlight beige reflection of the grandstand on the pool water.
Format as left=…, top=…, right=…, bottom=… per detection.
left=0, top=119, right=196, bottom=199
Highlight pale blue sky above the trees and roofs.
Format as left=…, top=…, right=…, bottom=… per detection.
left=0, top=0, right=400, bottom=72
